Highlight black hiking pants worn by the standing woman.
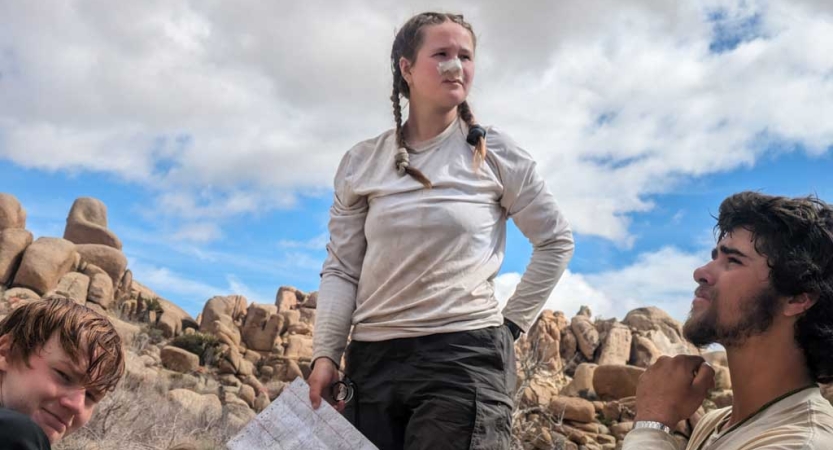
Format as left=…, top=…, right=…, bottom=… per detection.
left=344, top=326, right=516, bottom=450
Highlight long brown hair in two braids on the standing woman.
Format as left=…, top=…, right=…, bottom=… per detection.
left=390, top=12, right=486, bottom=189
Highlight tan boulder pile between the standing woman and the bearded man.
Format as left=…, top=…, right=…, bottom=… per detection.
left=514, top=307, right=731, bottom=450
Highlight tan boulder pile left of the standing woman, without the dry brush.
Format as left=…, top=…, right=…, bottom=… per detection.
left=0, top=194, right=317, bottom=432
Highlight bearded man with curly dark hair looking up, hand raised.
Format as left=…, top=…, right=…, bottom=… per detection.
left=623, top=192, right=833, bottom=450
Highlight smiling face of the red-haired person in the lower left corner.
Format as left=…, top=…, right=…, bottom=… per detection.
left=0, top=335, right=104, bottom=444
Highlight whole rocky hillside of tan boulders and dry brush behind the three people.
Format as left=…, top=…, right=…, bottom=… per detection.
left=0, top=194, right=833, bottom=450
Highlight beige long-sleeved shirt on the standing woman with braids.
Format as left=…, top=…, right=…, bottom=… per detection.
left=313, top=120, right=573, bottom=362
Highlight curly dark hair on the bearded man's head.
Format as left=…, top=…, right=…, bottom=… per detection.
left=715, top=192, right=833, bottom=383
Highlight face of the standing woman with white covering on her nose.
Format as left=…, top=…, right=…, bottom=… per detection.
left=400, top=22, right=474, bottom=110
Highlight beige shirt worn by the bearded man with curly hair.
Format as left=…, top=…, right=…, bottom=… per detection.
left=622, top=388, right=833, bottom=450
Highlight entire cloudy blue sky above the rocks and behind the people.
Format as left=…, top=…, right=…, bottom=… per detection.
left=0, top=0, right=833, bottom=319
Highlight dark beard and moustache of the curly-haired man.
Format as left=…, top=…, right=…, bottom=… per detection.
left=683, top=286, right=779, bottom=347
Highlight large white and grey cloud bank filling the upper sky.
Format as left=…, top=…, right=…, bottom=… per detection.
left=0, top=0, right=833, bottom=246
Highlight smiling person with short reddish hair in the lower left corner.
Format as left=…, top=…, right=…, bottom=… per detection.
left=0, top=298, right=124, bottom=450
